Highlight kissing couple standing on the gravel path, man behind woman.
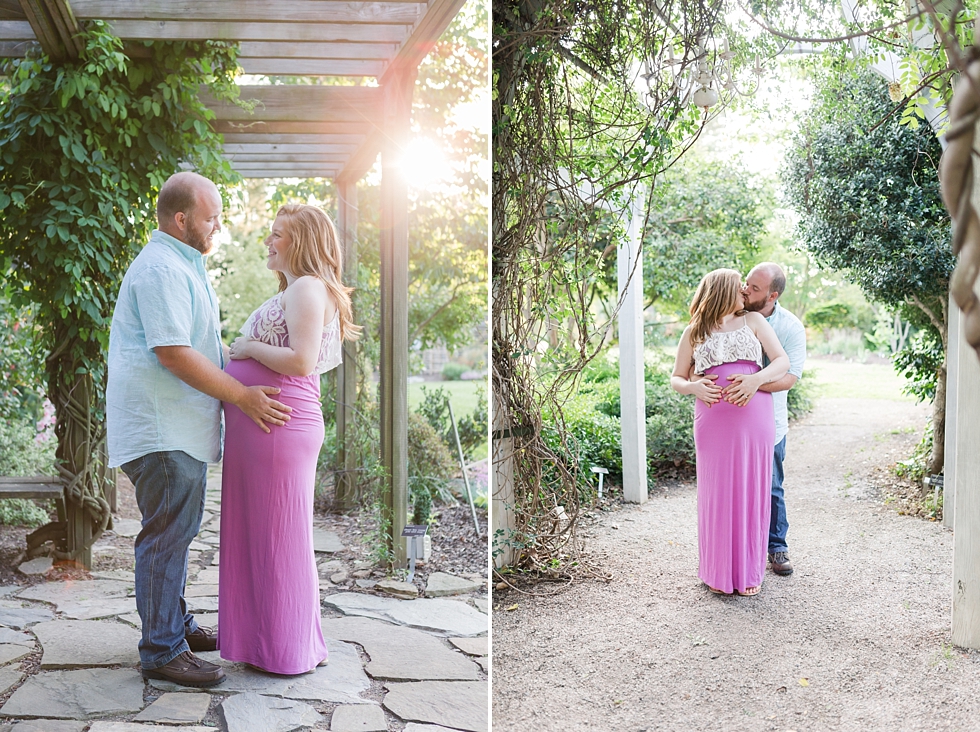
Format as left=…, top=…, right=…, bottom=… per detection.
left=670, top=262, right=806, bottom=595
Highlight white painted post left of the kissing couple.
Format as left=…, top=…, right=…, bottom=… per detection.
left=617, top=203, right=647, bottom=503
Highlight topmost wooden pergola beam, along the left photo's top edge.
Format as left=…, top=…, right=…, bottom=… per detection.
left=71, top=0, right=425, bottom=25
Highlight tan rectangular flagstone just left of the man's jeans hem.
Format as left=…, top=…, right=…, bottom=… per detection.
left=34, top=620, right=140, bottom=668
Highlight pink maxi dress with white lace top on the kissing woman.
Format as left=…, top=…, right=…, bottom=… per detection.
left=694, top=325, right=776, bottom=593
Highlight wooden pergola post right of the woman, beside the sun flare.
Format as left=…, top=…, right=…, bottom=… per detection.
left=380, top=68, right=417, bottom=567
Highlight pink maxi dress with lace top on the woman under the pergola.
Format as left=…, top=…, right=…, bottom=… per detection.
left=218, top=293, right=341, bottom=674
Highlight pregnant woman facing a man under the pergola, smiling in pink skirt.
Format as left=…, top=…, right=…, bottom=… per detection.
left=218, top=205, right=360, bottom=674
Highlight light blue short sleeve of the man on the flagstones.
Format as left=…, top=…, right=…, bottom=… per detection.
left=132, top=267, right=194, bottom=350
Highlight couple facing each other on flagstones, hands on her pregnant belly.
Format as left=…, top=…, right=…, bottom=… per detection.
left=106, top=172, right=360, bottom=687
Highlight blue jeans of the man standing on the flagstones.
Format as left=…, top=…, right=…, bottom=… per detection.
left=122, top=451, right=208, bottom=670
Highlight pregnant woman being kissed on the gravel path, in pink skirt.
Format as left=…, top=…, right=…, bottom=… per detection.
left=670, top=269, right=789, bottom=595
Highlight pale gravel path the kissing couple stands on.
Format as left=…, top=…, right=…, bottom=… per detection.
left=492, top=392, right=980, bottom=732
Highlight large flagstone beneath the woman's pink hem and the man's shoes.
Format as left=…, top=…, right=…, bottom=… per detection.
left=150, top=640, right=373, bottom=704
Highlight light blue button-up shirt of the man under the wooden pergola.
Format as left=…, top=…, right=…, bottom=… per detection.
left=106, top=229, right=224, bottom=467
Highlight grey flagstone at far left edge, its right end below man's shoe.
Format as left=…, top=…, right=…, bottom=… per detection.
left=0, top=668, right=143, bottom=719
